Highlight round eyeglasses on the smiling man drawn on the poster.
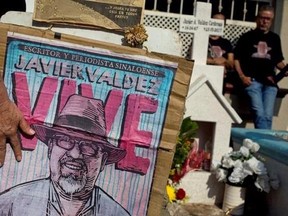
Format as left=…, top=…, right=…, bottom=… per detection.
left=53, top=135, right=102, bottom=156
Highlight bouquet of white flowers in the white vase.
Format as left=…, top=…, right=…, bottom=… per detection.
left=212, top=139, right=279, bottom=193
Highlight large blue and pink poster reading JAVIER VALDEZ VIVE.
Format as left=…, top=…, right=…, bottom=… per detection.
left=0, top=32, right=177, bottom=216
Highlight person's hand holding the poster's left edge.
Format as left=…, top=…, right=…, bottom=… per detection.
left=0, top=100, right=35, bottom=167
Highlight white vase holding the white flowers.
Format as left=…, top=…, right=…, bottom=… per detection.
left=222, top=184, right=246, bottom=216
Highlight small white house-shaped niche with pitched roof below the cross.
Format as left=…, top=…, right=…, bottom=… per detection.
left=185, top=76, right=241, bottom=161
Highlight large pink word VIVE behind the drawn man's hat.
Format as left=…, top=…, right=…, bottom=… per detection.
left=12, top=72, right=158, bottom=175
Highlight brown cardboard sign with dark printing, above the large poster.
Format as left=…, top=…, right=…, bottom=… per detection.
left=33, top=0, right=145, bottom=29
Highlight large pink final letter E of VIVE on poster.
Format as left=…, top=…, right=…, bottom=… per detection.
left=117, top=94, right=158, bottom=175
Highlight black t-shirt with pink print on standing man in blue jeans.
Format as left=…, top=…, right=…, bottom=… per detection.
left=234, top=29, right=284, bottom=82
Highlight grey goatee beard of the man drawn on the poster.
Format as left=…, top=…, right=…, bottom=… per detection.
left=58, top=173, right=87, bottom=195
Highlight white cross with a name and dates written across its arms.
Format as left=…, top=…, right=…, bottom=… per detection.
left=180, top=2, right=224, bottom=65
